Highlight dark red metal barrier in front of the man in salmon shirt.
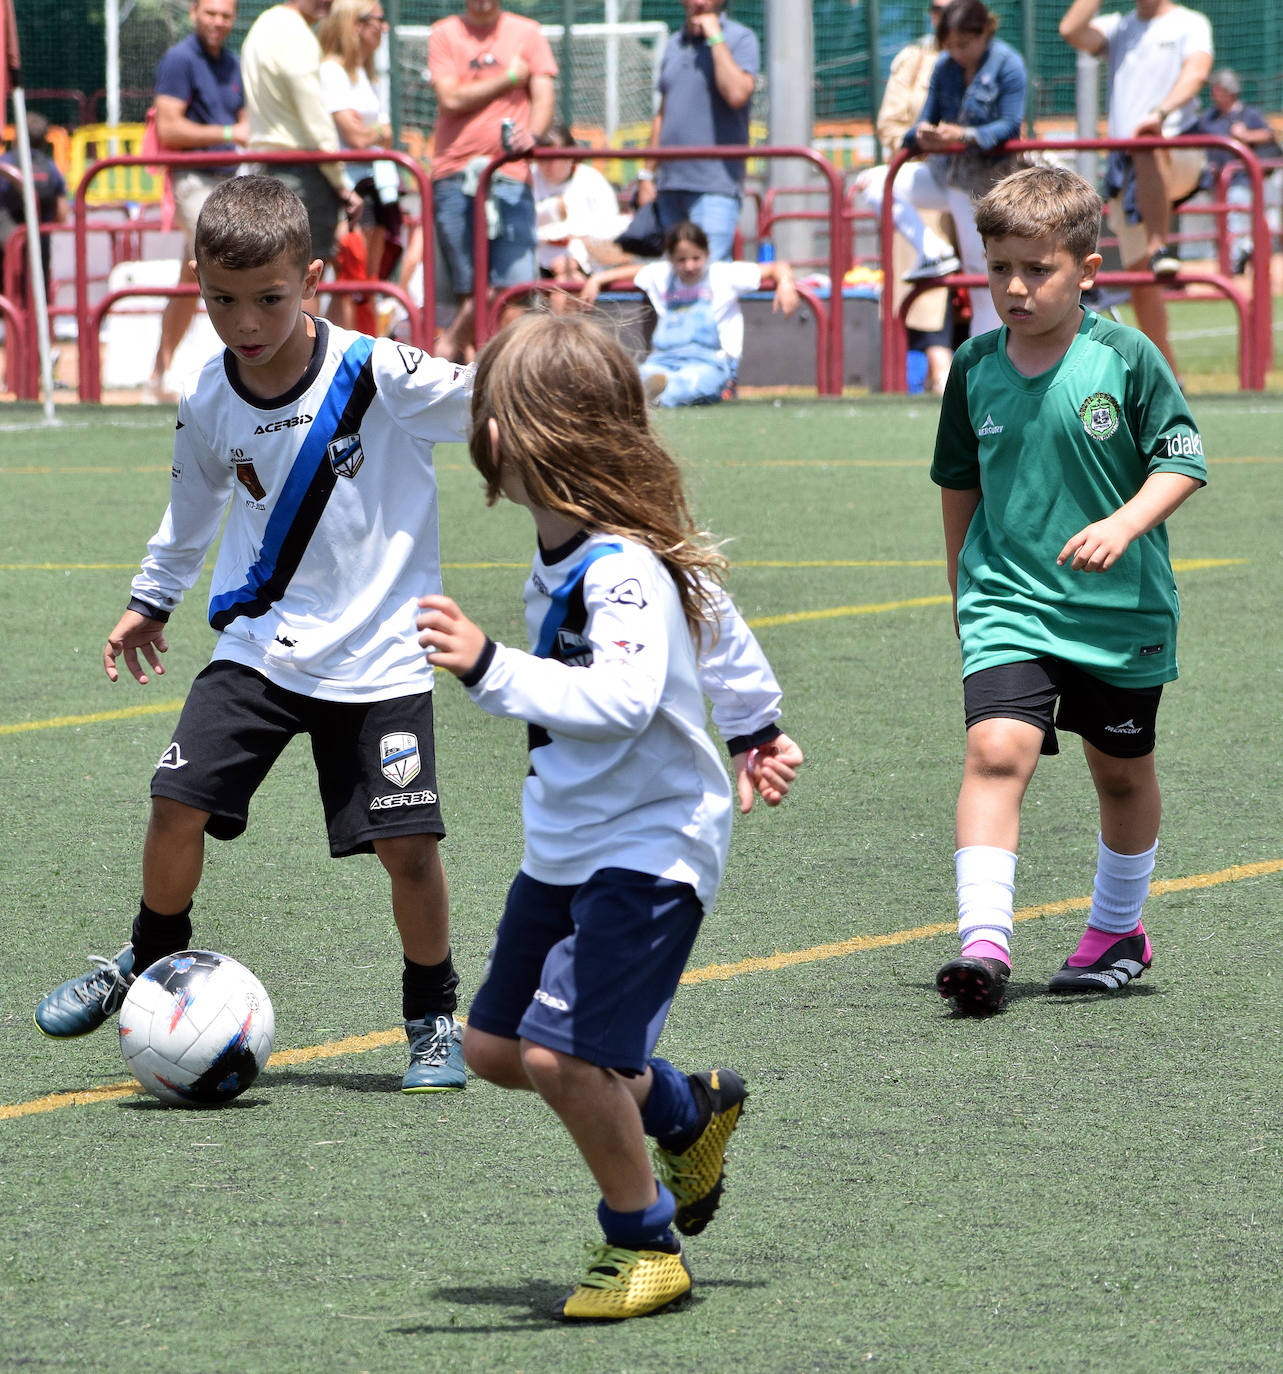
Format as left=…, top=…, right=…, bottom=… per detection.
left=473, top=144, right=846, bottom=396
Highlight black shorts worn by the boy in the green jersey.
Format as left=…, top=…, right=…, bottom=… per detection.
left=963, top=658, right=1162, bottom=758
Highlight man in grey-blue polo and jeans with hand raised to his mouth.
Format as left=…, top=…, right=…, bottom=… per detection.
left=637, top=0, right=761, bottom=262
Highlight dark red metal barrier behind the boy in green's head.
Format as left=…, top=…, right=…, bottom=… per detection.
left=881, top=133, right=1273, bottom=392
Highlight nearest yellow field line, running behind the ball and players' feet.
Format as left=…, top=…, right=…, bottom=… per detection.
left=0, top=859, right=1283, bottom=1121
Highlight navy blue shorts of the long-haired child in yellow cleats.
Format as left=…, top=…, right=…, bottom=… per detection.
left=468, top=868, right=703, bottom=1073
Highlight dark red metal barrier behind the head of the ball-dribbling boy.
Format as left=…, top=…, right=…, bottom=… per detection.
left=73, top=148, right=435, bottom=401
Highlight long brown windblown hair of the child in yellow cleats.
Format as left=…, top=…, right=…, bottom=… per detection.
left=468, top=311, right=725, bottom=632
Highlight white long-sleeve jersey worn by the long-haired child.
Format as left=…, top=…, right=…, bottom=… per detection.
left=464, top=534, right=780, bottom=910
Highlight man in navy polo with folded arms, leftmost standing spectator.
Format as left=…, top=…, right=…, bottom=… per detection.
left=143, top=0, right=250, bottom=401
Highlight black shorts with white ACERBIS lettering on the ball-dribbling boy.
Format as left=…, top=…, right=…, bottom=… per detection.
left=151, top=660, right=445, bottom=859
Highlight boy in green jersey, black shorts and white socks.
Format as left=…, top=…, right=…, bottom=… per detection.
left=931, top=166, right=1206, bottom=1015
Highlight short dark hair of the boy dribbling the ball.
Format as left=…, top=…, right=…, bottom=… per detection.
left=196, top=176, right=312, bottom=273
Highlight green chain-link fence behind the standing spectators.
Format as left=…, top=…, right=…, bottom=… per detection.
left=5, top=0, right=1283, bottom=151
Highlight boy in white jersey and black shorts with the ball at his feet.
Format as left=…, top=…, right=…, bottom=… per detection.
left=36, top=176, right=471, bottom=1092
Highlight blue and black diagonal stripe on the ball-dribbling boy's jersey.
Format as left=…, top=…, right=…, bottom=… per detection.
left=209, top=337, right=375, bottom=629
